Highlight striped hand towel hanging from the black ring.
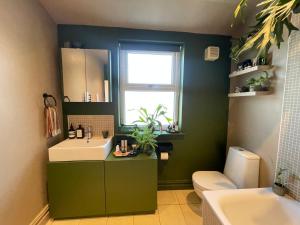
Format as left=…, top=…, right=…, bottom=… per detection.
left=45, top=106, right=61, bottom=138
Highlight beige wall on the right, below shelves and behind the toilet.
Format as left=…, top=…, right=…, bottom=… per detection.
left=227, top=33, right=288, bottom=187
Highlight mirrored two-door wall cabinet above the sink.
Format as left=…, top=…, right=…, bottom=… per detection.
left=61, top=48, right=111, bottom=102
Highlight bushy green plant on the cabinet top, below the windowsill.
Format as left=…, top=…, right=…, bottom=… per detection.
left=129, top=126, right=157, bottom=155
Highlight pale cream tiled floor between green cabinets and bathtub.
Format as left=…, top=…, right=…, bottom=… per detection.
left=47, top=190, right=203, bottom=225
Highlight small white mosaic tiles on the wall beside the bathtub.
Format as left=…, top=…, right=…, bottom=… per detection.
left=277, top=15, right=300, bottom=201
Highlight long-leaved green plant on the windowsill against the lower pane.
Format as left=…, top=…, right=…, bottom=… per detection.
left=133, top=104, right=172, bottom=132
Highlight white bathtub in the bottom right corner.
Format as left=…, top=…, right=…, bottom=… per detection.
left=203, top=188, right=300, bottom=225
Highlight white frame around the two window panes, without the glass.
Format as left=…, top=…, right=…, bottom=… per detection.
left=119, top=50, right=181, bottom=129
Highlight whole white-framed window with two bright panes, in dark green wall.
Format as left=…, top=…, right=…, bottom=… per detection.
left=120, top=44, right=181, bottom=128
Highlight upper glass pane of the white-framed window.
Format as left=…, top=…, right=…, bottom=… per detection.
left=128, top=53, right=173, bottom=84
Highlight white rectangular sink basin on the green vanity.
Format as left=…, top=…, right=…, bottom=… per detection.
left=48, top=137, right=112, bottom=162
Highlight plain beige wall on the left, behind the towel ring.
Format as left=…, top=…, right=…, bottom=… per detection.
left=0, top=0, right=61, bottom=225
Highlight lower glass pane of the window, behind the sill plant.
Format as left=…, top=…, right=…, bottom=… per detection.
left=124, top=91, right=175, bottom=125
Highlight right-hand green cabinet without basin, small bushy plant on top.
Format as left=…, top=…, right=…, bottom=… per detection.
left=105, top=152, right=157, bottom=215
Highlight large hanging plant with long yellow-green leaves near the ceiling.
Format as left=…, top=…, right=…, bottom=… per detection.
left=231, top=0, right=300, bottom=62
